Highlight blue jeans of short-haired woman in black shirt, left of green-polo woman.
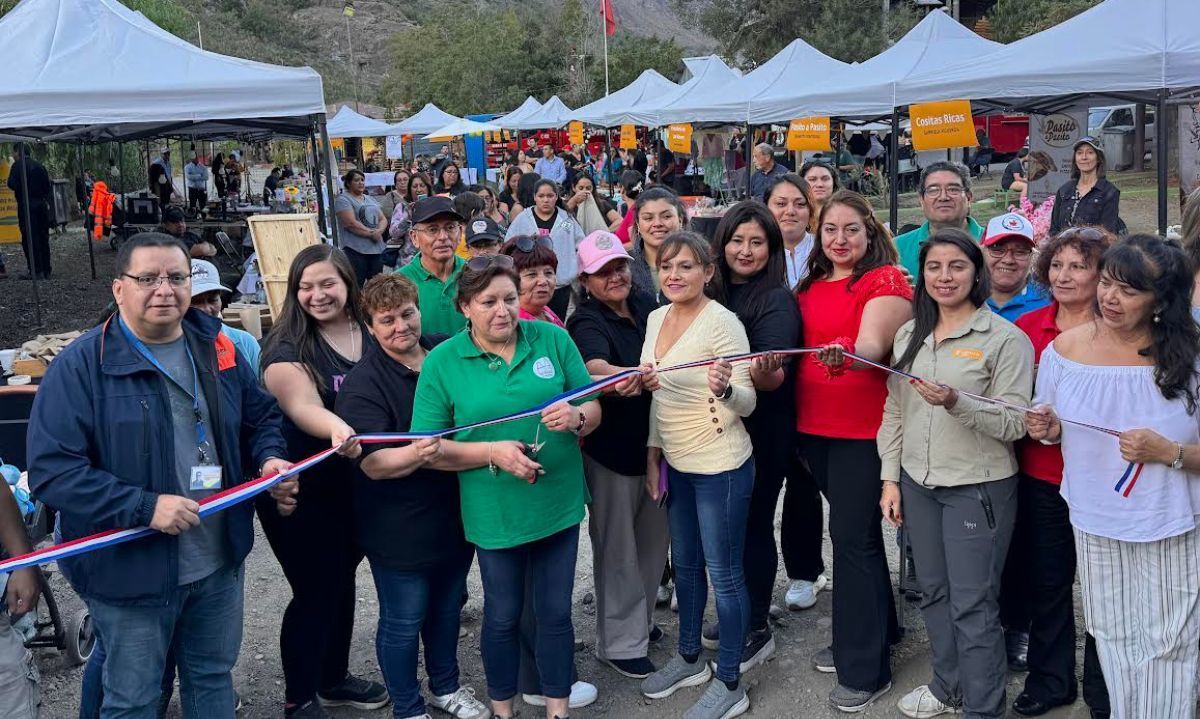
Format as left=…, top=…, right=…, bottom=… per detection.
left=371, top=562, right=470, bottom=719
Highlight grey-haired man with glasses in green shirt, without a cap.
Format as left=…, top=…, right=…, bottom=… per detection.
left=895, top=161, right=983, bottom=277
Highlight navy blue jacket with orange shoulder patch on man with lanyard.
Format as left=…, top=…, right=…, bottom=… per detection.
left=28, top=310, right=287, bottom=605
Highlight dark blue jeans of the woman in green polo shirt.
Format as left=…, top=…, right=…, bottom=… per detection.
left=476, top=525, right=580, bottom=701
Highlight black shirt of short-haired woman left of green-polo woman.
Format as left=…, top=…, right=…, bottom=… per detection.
left=336, top=335, right=468, bottom=571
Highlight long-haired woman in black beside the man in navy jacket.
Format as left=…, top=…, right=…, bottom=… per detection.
left=257, top=245, right=389, bottom=718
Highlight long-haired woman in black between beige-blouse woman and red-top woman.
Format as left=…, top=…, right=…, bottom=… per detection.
left=703, top=200, right=800, bottom=671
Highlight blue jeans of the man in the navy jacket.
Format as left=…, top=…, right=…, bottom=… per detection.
left=85, top=564, right=244, bottom=719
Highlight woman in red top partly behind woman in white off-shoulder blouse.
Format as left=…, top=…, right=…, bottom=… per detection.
left=1004, top=227, right=1116, bottom=717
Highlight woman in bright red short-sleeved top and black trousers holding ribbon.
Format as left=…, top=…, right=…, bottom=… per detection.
left=796, top=190, right=912, bottom=711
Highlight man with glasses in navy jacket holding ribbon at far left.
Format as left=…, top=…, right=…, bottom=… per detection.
left=29, top=233, right=289, bottom=719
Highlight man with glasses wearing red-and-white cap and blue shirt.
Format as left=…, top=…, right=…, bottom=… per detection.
left=982, top=212, right=1050, bottom=322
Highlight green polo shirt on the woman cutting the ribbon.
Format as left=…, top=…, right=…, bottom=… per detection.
left=413, top=320, right=595, bottom=550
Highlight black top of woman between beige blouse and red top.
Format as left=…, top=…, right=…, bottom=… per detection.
left=730, top=284, right=802, bottom=472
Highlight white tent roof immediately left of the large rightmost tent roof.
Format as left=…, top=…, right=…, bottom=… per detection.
left=750, top=10, right=1004, bottom=124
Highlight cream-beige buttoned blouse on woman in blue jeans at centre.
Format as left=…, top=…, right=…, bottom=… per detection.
left=642, top=301, right=757, bottom=474
